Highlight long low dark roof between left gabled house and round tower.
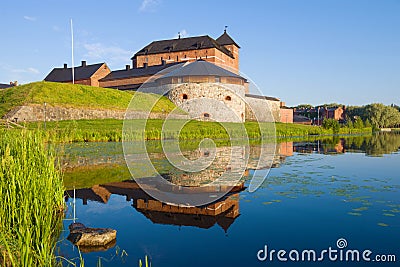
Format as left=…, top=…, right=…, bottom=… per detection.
left=99, top=62, right=184, bottom=82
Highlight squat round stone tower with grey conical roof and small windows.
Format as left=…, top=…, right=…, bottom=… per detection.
left=156, top=60, right=248, bottom=122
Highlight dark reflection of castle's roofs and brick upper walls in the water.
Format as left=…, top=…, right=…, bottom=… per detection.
left=65, top=180, right=244, bottom=232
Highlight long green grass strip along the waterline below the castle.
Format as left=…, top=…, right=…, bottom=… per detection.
left=18, top=119, right=372, bottom=143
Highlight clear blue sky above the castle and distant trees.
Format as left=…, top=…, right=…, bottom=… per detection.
left=0, top=0, right=400, bottom=105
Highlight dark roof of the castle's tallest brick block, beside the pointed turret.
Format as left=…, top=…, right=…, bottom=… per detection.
left=131, top=35, right=234, bottom=59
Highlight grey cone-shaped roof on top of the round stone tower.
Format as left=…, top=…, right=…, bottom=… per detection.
left=160, top=59, right=246, bottom=80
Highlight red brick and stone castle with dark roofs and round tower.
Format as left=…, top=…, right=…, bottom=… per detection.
left=44, top=29, right=293, bottom=122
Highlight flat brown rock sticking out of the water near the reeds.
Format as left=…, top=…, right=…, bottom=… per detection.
left=67, top=223, right=117, bottom=247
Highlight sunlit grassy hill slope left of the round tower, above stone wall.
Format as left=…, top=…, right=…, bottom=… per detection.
left=0, top=82, right=181, bottom=118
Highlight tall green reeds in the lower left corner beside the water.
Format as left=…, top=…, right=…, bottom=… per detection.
left=0, top=131, right=65, bottom=266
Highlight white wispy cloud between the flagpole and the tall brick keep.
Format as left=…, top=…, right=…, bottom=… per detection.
left=83, top=43, right=132, bottom=64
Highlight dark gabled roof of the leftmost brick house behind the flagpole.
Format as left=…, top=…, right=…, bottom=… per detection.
left=44, top=63, right=107, bottom=82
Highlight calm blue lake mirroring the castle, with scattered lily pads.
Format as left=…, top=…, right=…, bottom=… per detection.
left=56, top=133, right=400, bottom=267
